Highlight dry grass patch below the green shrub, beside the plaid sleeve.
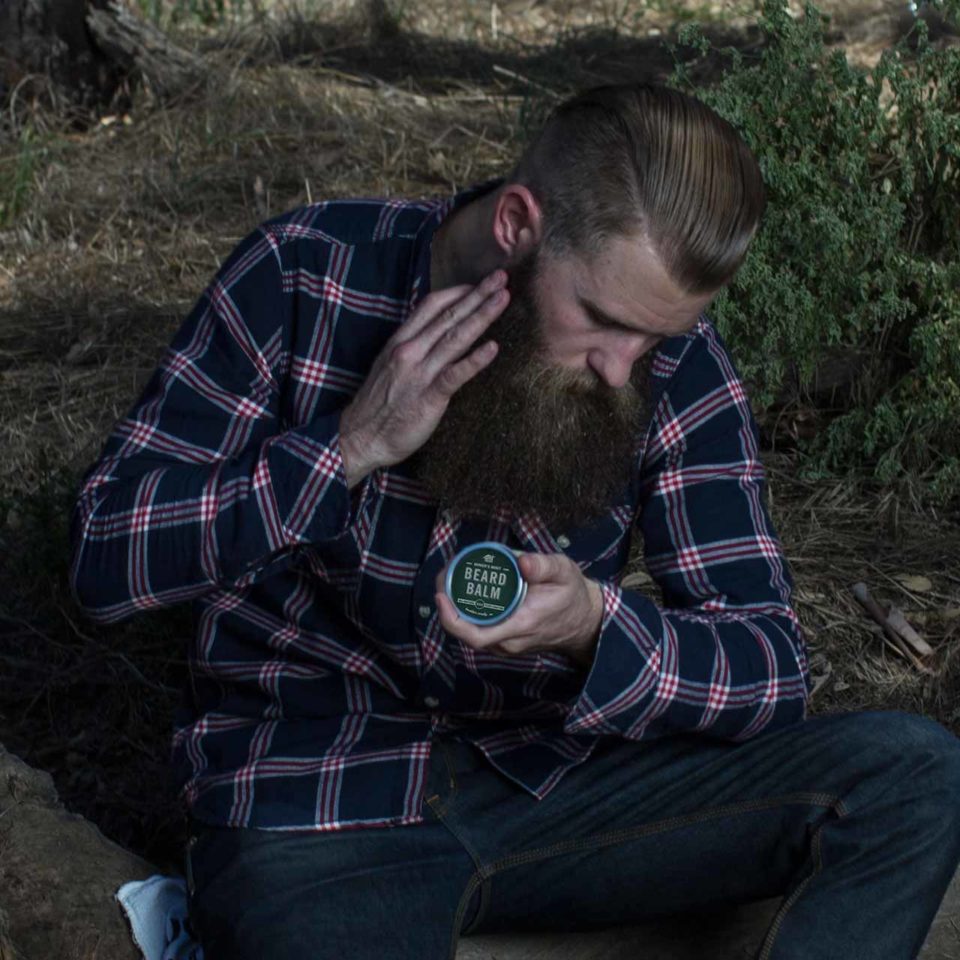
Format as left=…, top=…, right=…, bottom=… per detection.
left=766, top=456, right=960, bottom=720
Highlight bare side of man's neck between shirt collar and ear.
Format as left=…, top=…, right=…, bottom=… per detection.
left=430, top=190, right=502, bottom=290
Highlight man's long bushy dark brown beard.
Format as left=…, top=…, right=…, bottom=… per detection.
left=411, top=254, right=652, bottom=528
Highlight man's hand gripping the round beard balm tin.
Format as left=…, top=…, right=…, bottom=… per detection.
left=435, top=553, right=603, bottom=667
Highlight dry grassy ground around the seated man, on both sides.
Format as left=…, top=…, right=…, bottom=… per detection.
left=0, top=0, right=960, bottom=866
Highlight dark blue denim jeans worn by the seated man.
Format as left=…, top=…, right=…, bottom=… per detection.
left=187, top=711, right=960, bottom=960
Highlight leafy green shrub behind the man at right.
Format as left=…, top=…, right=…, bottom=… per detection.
left=670, top=0, right=960, bottom=502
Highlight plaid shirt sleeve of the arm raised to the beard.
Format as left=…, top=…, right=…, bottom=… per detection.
left=70, top=230, right=372, bottom=623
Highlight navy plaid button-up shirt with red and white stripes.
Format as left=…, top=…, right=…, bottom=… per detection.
left=71, top=184, right=810, bottom=830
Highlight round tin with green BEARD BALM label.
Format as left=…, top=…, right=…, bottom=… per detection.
left=446, top=540, right=527, bottom=626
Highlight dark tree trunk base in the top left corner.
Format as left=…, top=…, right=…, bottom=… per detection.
left=0, top=0, right=116, bottom=102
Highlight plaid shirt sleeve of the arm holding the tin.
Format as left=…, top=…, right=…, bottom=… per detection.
left=564, top=324, right=812, bottom=740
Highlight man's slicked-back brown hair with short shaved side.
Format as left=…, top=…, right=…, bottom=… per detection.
left=507, top=83, right=766, bottom=295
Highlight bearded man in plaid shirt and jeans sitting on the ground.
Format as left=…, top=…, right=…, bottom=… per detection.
left=72, top=85, right=960, bottom=960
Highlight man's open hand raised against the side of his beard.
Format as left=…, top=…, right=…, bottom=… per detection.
left=340, top=270, right=510, bottom=485
